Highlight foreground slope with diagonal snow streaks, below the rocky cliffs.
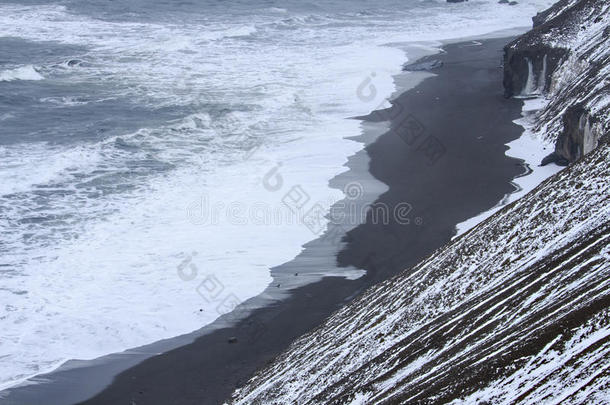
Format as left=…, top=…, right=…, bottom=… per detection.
left=232, top=135, right=610, bottom=403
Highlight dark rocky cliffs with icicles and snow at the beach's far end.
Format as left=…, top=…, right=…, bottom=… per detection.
left=504, top=0, right=610, bottom=164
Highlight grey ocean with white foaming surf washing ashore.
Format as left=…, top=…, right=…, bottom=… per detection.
left=0, top=0, right=552, bottom=390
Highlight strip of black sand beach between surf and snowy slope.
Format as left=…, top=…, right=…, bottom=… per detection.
left=0, top=38, right=524, bottom=405
